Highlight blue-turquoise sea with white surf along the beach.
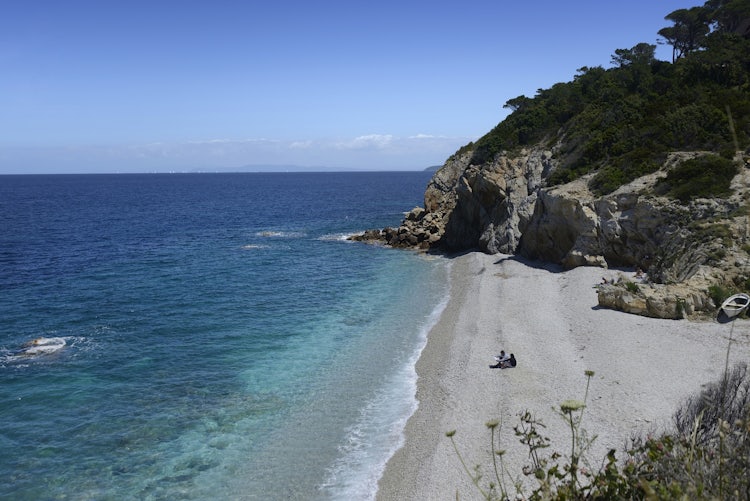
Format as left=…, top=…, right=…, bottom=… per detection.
left=0, top=172, right=449, bottom=500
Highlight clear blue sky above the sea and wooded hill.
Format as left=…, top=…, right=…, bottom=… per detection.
left=0, top=0, right=704, bottom=174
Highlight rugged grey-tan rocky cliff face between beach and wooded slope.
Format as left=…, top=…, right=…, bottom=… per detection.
left=356, top=146, right=750, bottom=318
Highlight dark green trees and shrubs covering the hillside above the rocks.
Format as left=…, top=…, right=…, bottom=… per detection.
left=460, top=0, right=750, bottom=199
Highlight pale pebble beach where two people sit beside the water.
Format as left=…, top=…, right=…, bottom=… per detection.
left=377, top=253, right=750, bottom=500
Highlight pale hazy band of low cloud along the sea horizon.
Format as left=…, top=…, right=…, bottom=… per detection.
left=0, top=134, right=472, bottom=173
